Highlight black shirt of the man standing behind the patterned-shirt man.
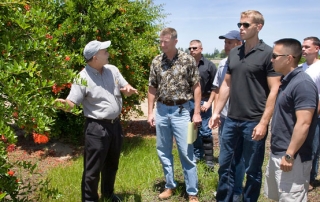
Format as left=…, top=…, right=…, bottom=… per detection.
left=198, top=56, right=217, bottom=97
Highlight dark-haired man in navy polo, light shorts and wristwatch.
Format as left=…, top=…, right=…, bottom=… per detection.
left=264, top=39, right=319, bottom=202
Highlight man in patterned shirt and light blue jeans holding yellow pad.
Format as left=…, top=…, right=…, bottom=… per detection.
left=148, top=27, right=201, bottom=202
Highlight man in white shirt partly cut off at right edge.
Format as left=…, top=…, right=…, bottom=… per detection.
left=302, top=36, right=320, bottom=191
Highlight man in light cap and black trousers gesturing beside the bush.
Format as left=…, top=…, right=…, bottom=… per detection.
left=56, top=41, right=138, bottom=202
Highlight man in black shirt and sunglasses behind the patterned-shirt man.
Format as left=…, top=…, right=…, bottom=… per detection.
left=189, top=40, right=217, bottom=170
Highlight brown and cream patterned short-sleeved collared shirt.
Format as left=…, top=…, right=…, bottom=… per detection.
left=149, top=50, right=200, bottom=100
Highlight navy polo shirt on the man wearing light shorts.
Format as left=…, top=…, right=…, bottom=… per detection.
left=271, top=67, right=319, bottom=162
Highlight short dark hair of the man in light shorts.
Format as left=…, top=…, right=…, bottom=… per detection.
left=274, top=38, right=302, bottom=65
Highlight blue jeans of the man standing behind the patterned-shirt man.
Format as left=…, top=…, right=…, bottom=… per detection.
left=190, top=100, right=213, bottom=160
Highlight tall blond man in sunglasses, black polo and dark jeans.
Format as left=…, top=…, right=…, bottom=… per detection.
left=210, top=10, right=280, bottom=201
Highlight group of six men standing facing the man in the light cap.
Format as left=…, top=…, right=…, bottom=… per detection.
left=148, top=10, right=320, bottom=201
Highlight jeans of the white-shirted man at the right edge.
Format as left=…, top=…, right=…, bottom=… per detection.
left=310, top=118, right=320, bottom=182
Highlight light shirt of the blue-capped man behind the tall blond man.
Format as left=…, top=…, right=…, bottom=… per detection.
left=213, top=57, right=229, bottom=118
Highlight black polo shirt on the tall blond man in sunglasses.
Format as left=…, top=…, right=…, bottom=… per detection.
left=227, top=40, right=280, bottom=121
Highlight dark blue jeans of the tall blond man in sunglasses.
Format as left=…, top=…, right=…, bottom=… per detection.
left=216, top=117, right=267, bottom=201
